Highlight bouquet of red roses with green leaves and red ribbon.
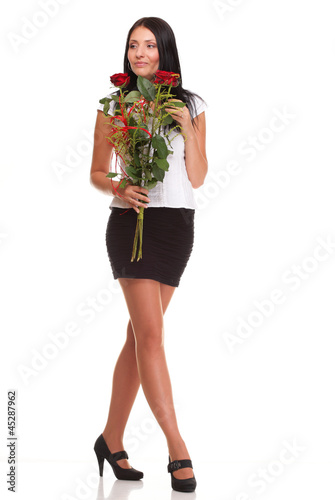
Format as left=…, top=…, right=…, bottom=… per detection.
left=99, top=71, right=185, bottom=262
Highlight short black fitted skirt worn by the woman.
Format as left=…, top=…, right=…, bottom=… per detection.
left=106, top=207, right=195, bottom=287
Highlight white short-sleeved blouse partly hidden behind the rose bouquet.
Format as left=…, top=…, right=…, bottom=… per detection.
left=98, top=94, right=207, bottom=209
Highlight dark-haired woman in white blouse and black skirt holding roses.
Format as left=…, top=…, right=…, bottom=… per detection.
left=91, top=17, right=208, bottom=491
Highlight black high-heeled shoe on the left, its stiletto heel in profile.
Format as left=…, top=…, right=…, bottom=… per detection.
left=94, top=434, right=143, bottom=481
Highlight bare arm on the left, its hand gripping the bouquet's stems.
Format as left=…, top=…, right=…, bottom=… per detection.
left=90, top=110, right=149, bottom=213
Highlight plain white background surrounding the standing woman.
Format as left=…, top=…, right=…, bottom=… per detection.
left=0, top=0, right=335, bottom=500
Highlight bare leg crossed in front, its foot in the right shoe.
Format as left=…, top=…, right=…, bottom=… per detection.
left=119, top=278, right=193, bottom=479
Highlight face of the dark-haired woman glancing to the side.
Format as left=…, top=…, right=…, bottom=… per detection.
left=128, top=26, right=159, bottom=80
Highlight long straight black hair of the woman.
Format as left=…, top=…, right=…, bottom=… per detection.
left=123, top=17, right=201, bottom=127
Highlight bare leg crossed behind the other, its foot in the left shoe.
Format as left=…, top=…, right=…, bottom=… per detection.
left=102, top=283, right=175, bottom=468
